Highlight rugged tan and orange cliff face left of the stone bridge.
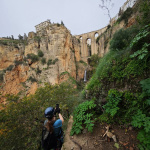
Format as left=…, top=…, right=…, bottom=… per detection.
left=0, top=24, right=85, bottom=104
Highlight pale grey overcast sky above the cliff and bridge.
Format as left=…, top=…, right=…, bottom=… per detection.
left=0, top=0, right=126, bottom=38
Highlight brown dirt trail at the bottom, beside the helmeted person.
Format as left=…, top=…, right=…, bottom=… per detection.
left=62, top=116, right=138, bottom=150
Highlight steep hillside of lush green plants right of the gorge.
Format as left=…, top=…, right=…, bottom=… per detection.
left=72, top=6, right=150, bottom=150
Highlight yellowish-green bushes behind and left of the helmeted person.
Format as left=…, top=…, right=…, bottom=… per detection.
left=0, top=84, right=80, bottom=150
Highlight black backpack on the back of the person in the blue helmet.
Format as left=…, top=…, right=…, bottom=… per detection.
left=41, top=127, right=57, bottom=150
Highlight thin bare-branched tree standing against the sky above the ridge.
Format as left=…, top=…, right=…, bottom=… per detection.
left=99, top=0, right=114, bottom=21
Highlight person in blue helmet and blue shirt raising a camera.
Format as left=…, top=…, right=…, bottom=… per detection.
left=42, top=104, right=64, bottom=150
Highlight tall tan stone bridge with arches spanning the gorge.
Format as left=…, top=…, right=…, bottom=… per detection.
left=75, top=27, right=107, bottom=61
